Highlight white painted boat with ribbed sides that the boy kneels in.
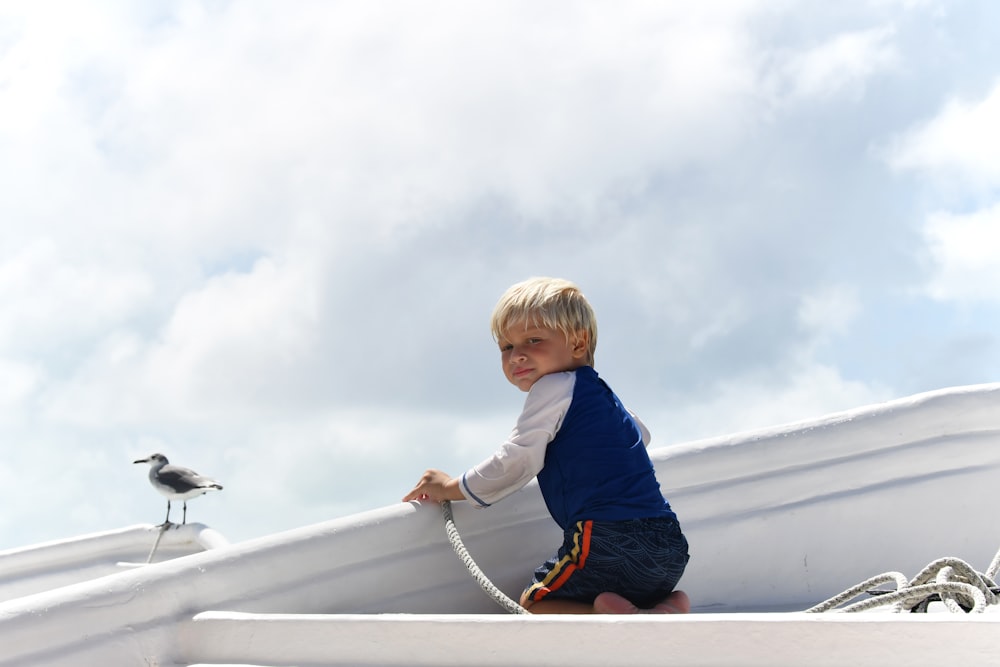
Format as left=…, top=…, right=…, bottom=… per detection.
left=0, top=385, right=1000, bottom=666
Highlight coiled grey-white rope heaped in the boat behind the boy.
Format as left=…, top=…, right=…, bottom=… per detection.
left=806, top=551, right=1000, bottom=613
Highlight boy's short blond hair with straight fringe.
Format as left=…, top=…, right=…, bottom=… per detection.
left=490, top=278, right=597, bottom=365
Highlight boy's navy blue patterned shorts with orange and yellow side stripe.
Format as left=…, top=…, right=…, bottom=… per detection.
left=523, top=517, right=689, bottom=607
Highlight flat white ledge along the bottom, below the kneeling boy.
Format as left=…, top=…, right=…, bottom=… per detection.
left=178, top=613, right=1000, bottom=667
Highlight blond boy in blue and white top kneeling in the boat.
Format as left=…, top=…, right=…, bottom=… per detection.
left=403, top=278, right=691, bottom=614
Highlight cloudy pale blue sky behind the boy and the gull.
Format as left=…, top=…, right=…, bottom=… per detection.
left=0, top=0, right=1000, bottom=550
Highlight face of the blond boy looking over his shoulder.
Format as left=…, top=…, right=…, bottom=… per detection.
left=498, top=322, right=588, bottom=391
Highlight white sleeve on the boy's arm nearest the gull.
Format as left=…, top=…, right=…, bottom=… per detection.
left=460, top=373, right=576, bottom=507
